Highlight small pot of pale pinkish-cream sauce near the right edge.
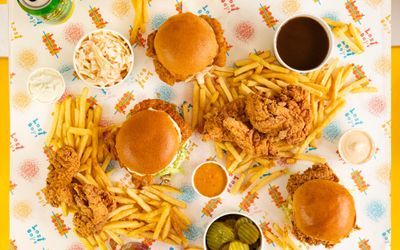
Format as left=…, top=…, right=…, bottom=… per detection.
left=339, top=130, right=375, bottom=164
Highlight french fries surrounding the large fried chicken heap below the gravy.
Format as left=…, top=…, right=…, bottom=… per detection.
left=182, top=51, right=377, bottom=193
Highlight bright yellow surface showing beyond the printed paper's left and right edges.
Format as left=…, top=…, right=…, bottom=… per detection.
left=0, top=0, right=400, bottom=246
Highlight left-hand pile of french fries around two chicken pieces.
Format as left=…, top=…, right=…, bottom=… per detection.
left=46, top=88, right=195, bottom=249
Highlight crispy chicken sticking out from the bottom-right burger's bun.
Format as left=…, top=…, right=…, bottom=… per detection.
left=286, top=164, right=339, bottom=248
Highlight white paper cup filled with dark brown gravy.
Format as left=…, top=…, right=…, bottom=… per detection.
left=274, top=14, right=334, bottom=73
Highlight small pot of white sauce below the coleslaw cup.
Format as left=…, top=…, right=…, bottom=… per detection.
left=28, top=68, right=65, bottom=103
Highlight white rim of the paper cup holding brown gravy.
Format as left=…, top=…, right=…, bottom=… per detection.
left=273, top=13, right=335, bottom=73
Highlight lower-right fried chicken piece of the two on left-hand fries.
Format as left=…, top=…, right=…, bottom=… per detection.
left=72, top=183, right=116, bottom=237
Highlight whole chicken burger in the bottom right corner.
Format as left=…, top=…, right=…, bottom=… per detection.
left=286, top=164, right=356, bottom=248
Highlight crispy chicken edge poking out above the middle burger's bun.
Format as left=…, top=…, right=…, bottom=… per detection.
left=130, top=99, right=192, bottom=144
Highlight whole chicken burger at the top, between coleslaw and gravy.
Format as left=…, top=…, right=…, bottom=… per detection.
left=146, top=12, right=227, bottom=85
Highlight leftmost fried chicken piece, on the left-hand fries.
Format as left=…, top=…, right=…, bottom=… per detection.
left=43, top=146, right=80, bottom=207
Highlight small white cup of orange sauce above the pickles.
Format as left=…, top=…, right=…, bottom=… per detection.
left=192, top=161, right=229, bottom=199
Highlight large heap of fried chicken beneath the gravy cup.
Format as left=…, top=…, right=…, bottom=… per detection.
left=202, top=86, right=311, bottom=158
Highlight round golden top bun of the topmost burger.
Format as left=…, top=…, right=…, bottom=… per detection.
left=154, top=12, right=218, bottom=78
